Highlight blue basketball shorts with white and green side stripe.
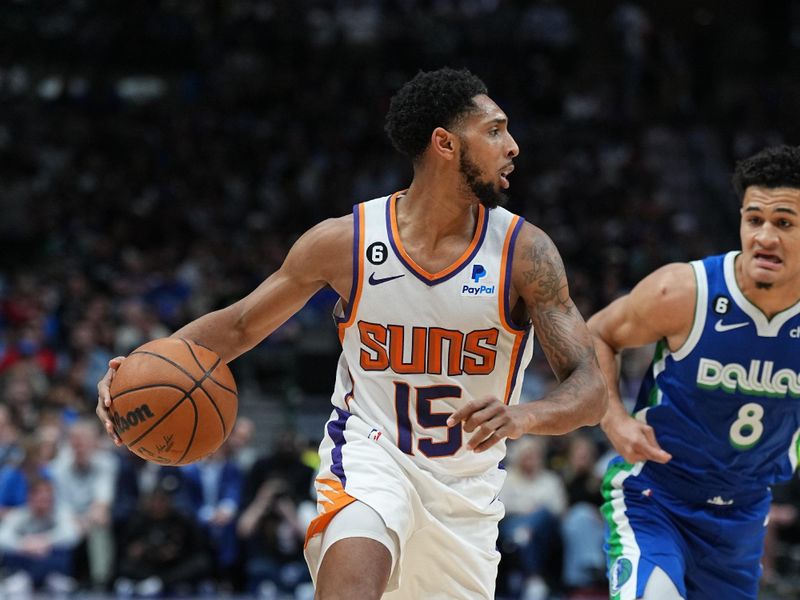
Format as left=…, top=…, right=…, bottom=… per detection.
left=602, top=457, right=772, bottom=600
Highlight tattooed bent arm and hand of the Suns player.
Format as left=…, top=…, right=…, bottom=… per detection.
left=448, top=223, right=606, bottom=450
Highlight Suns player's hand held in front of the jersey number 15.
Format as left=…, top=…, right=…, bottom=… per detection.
left=447, top=397, right=525, bottom=452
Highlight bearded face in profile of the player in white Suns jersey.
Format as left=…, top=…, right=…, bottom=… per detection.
left=459, top=94, right=519, bottom=208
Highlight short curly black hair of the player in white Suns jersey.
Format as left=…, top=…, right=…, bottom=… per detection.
left=384, top=67, right=487, bottom=161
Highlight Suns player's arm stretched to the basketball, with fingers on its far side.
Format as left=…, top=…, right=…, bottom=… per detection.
left=95, top=216, right=353, bottom=444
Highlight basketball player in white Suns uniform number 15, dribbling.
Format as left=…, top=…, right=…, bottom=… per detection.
left=97, top=68, right=606, bottom=600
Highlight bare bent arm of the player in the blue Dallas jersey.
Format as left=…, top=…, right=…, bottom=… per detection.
left=588, top=263, right=696, bottom=464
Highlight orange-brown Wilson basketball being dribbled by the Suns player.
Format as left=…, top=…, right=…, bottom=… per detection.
left=110, top=338, right=238, bottom=465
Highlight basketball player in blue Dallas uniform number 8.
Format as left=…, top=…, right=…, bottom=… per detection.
left=589, top=146, right=800, bottom=600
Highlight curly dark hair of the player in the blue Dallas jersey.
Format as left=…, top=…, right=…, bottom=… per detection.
left=731, top=146, right=800, bottom=201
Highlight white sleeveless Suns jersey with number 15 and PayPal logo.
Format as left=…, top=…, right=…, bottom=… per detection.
left=333, top=192, right=533, bottom=476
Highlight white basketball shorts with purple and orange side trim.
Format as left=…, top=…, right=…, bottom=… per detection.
left=305, top=409, right=505, bottom=600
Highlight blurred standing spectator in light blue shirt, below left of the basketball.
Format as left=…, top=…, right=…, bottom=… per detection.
left=51, top=419, right=116, bottom=588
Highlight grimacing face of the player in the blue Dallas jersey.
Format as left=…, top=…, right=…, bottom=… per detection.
left=739, top=186, right=800, bottom=289
